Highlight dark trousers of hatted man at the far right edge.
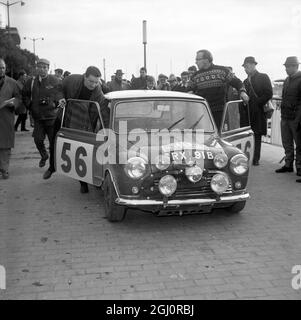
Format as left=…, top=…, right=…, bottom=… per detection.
left=281, top=119, right=301, bottom=169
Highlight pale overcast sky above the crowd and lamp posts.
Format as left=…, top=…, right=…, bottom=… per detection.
left=0, top=0, right=301, bottom=81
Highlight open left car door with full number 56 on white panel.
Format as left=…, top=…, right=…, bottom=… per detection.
left=55, top=99, right=104, bottom=186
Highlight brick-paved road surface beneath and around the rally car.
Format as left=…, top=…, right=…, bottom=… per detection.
left=0, top=129, right=301, bottom=299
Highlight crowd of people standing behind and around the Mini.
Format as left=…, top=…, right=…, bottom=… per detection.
left=0, top=50, right=301, bottom=189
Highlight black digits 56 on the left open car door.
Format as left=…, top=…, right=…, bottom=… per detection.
left=61, top=142, right=87, bottom=178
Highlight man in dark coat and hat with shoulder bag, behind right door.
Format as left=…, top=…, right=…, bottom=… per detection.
left=242, top=57, right=273, bottom=166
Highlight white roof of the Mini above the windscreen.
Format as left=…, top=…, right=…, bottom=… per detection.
left=105, top=90, right=205, bottom=101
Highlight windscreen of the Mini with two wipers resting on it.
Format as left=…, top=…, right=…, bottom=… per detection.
left=113, top=100, right=214, bottom=133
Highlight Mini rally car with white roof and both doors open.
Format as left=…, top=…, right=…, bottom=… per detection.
left=55, top=90, right=254, bottom=222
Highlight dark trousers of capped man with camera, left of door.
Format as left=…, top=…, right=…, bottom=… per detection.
left=32, top=120, right=54, bottom=162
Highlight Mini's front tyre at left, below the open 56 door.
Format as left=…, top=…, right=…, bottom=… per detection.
left=103, top=174, right=127, bottom=222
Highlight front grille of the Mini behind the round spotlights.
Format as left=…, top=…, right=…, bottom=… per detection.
left=146, top=171, right=232, bottom=199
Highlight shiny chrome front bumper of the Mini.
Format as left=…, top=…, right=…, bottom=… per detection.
left=115, top=193, right=250, bottom=208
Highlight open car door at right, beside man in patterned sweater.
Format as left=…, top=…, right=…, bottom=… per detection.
left=220, top=100, right=254, bottom=162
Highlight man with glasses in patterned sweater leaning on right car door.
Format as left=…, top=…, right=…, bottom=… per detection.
left=189, top=50, right=249, bottom=128
